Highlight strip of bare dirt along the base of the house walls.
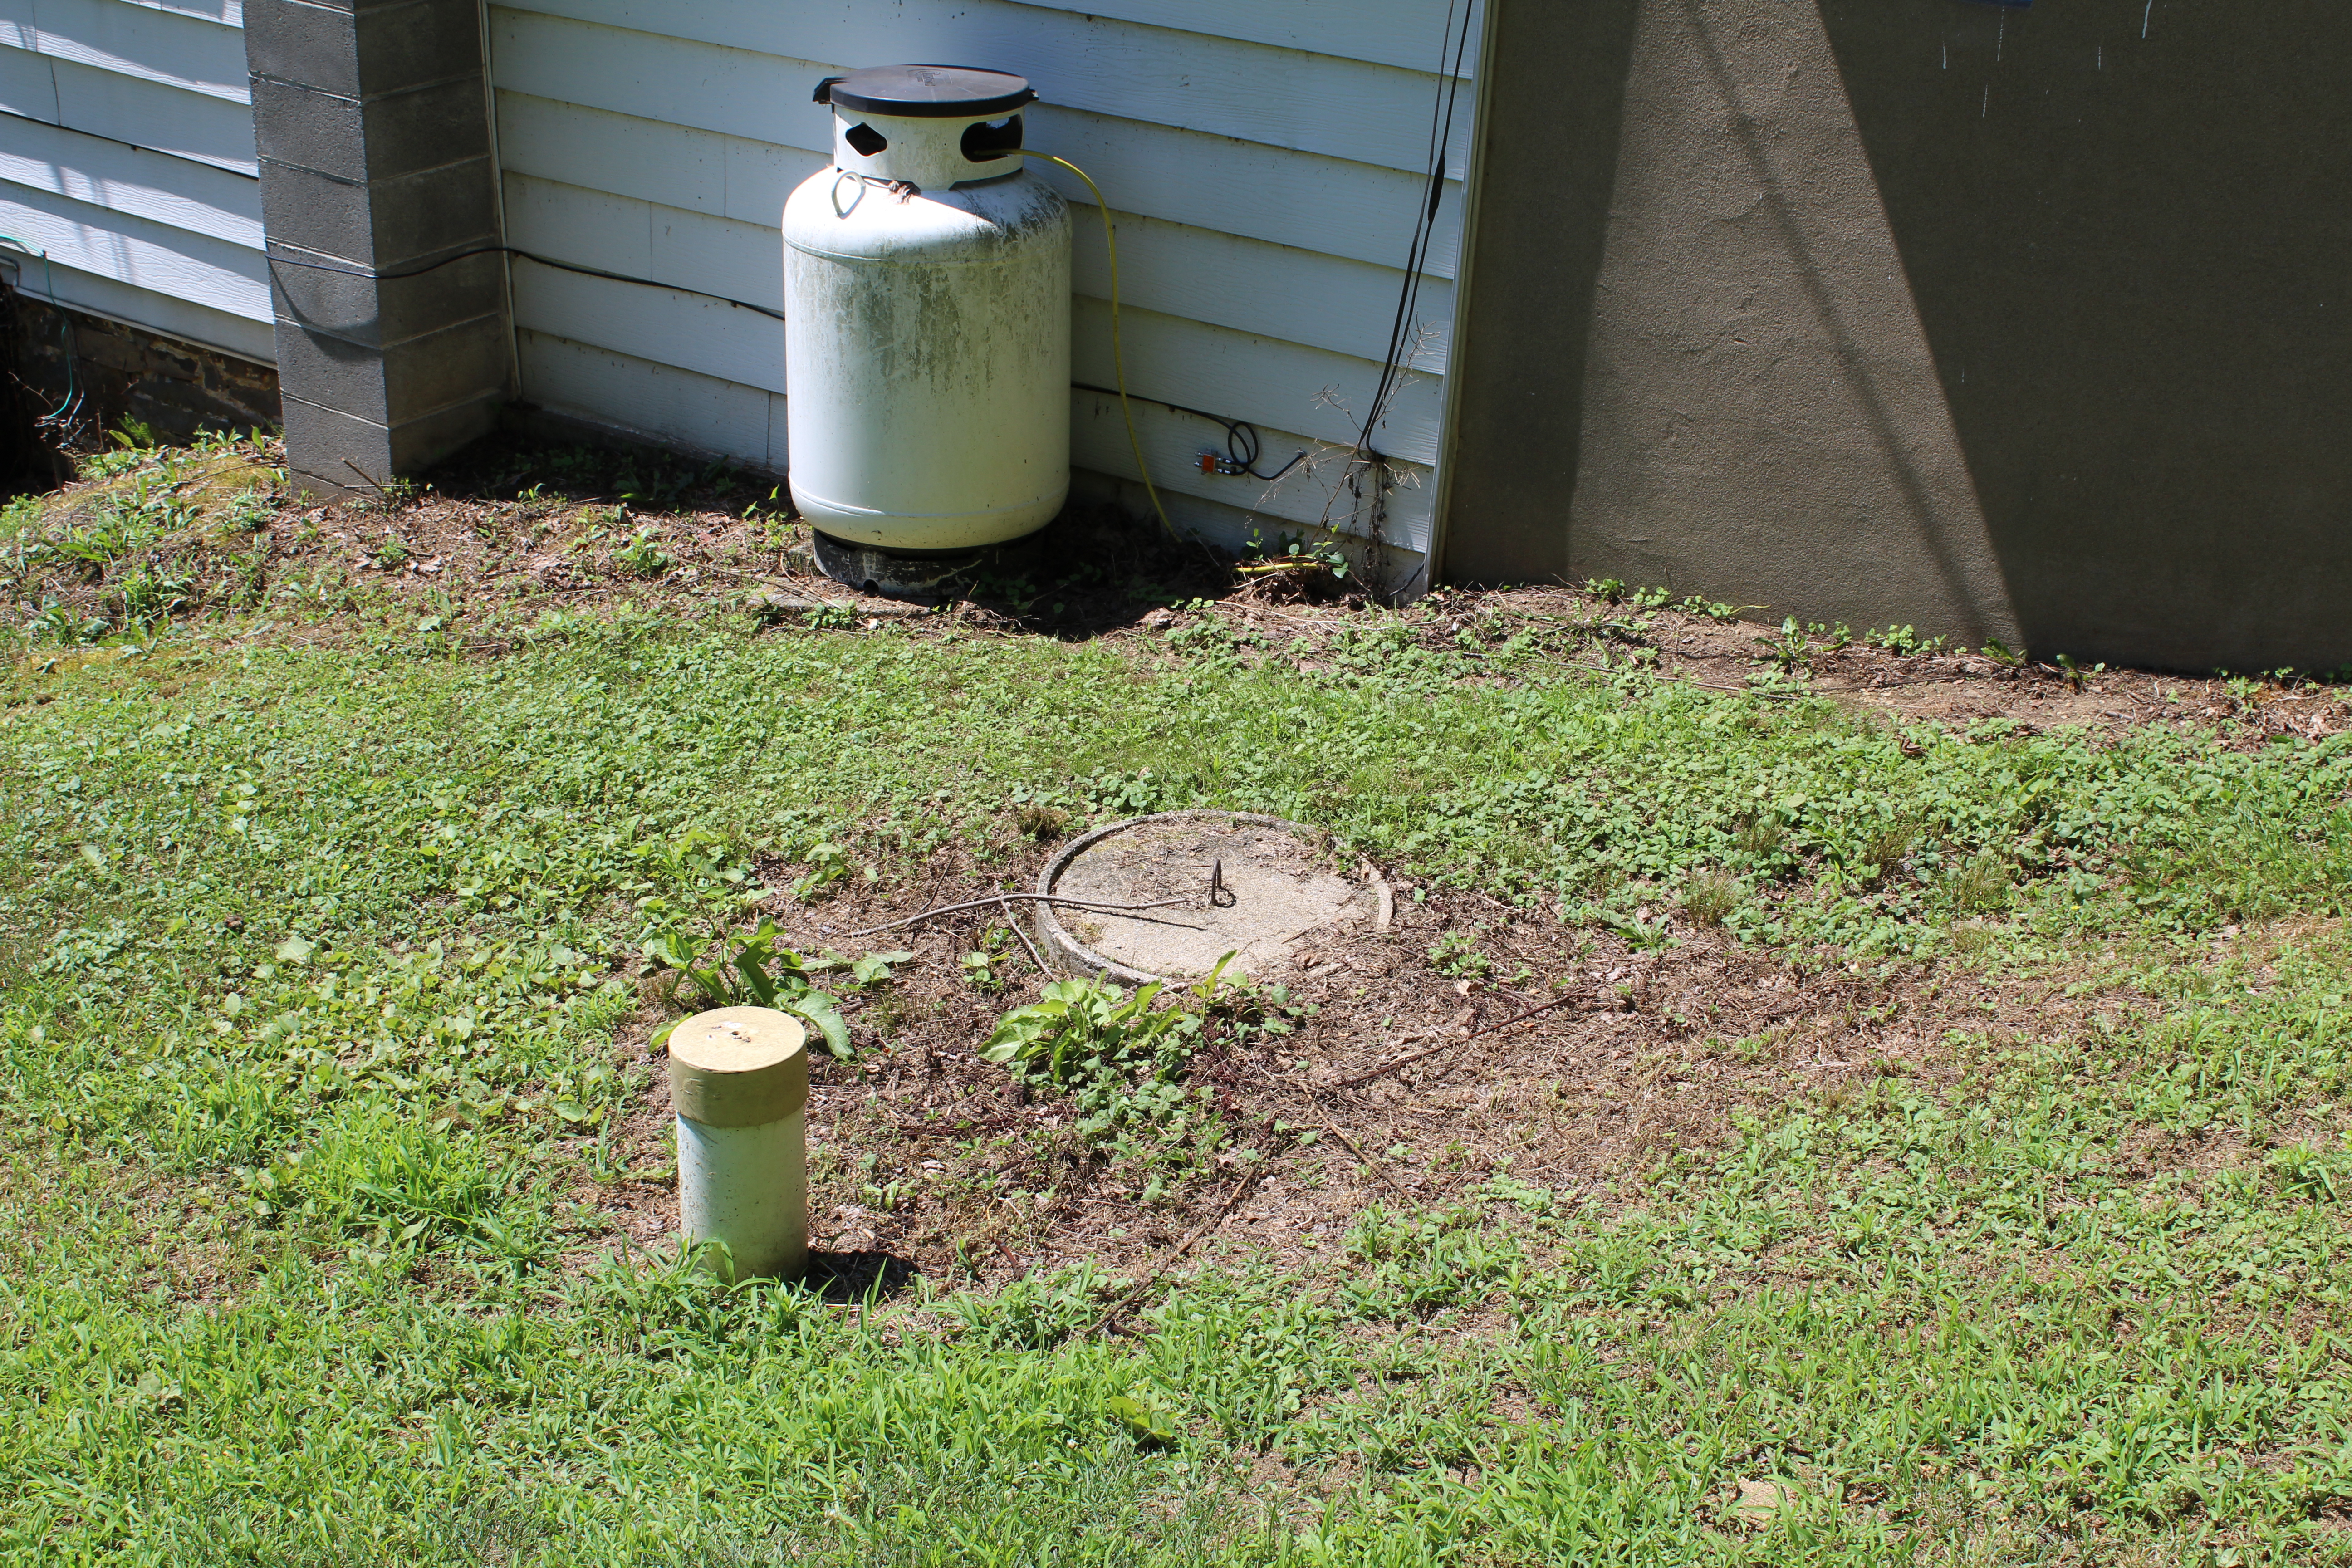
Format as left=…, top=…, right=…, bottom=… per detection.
left=14, top=435, right=2352, bottom=748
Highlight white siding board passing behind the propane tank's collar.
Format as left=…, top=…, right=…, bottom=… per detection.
left=491, top=23, right=1463, bottom=277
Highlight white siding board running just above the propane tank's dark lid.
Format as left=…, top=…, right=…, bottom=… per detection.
left=499, top=0, right=1470, bottom=169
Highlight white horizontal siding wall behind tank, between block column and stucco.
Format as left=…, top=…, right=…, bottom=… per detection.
left=489, top=0, right=1472, bottom=564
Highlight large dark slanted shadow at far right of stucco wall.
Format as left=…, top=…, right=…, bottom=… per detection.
left=1820, top=0, right=2352, bottom=670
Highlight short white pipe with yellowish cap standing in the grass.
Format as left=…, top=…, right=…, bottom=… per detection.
left=670, top=1006, right=809, bottom=1279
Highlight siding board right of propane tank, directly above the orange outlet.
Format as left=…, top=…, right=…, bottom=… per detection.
left=1070, top=299, right=1442, bottom=463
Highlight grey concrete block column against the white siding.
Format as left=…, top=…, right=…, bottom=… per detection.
left=245, top=0, right=513, bottom=496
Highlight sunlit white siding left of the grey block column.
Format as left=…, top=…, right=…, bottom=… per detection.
left=0, top=0, right=275, bottom=364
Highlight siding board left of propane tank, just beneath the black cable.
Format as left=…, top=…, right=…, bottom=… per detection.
left=515, top=259, right=783, bottom=392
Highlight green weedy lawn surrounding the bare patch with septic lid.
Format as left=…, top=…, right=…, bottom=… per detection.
left=0, top=592, right=2352, bottom=1566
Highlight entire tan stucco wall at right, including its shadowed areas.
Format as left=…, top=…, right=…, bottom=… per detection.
left=1446, top=0, right=2352, bottom=670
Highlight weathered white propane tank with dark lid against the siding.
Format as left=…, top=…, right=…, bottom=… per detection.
left=783, top=66, right=1070, bottom=553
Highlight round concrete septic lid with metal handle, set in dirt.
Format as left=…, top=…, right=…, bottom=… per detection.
left=1033, top=811, right=1395, bottom=985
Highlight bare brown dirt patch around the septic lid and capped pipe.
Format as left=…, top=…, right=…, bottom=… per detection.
left=559, top=848, right=2117, bottom=1284
